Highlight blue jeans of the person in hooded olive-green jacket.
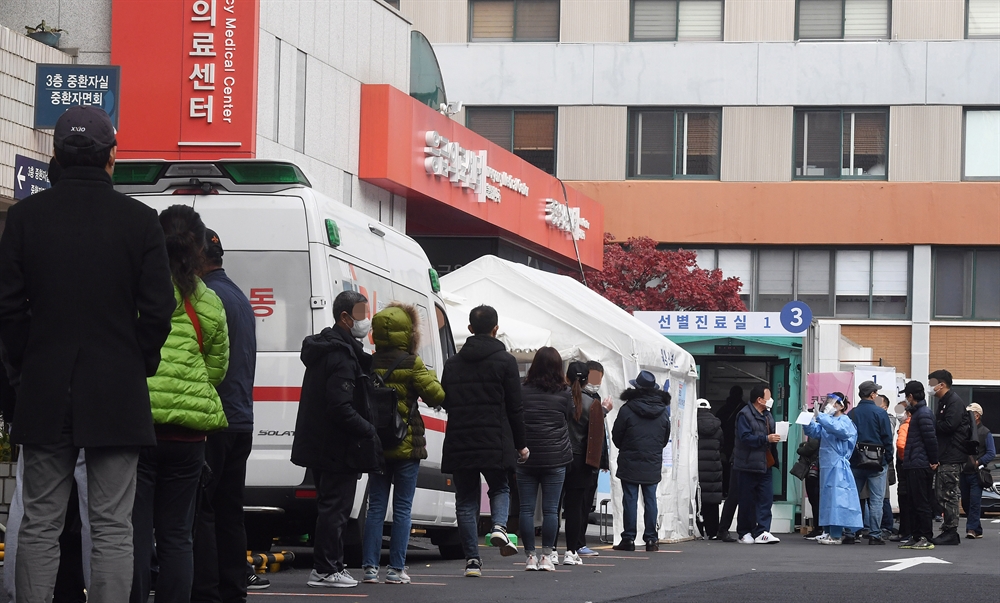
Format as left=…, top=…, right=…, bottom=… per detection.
left=361, top=461, right=420, bottom=570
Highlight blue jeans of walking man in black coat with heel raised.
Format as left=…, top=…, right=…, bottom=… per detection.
left=451, top=469, right=510, bottom=559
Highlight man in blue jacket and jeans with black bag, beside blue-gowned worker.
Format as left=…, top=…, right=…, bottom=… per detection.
left=844, top=381, right=893, bottom=545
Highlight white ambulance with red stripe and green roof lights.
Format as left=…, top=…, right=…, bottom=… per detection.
left=114, top=160, right=462, bottom=561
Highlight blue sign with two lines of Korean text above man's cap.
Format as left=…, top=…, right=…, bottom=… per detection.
left=35, top=63, right=121, bottom=129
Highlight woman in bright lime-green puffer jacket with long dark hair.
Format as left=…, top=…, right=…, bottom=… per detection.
left=129, top=205, right=229, bottom=603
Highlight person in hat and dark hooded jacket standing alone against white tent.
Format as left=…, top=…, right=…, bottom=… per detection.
left=611, top=371, right=670, bottom=551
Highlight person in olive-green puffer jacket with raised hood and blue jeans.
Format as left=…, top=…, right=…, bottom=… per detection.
left=361, top=303, right=444, bottom=584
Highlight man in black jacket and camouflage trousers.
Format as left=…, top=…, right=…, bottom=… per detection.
left=927, top=370, right=974, bottom=546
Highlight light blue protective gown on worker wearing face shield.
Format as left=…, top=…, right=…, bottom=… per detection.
left=804, top=414, right=864, bottom=529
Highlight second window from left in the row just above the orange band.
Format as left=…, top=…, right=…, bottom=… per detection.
left=627, top=109, right=722, bottom=179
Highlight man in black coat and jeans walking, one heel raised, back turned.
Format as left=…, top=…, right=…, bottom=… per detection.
left=441, top=306, right=528, bottom=578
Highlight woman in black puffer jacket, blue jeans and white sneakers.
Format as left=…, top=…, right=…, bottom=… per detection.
left=517, top=346, right=575, bottom=572
